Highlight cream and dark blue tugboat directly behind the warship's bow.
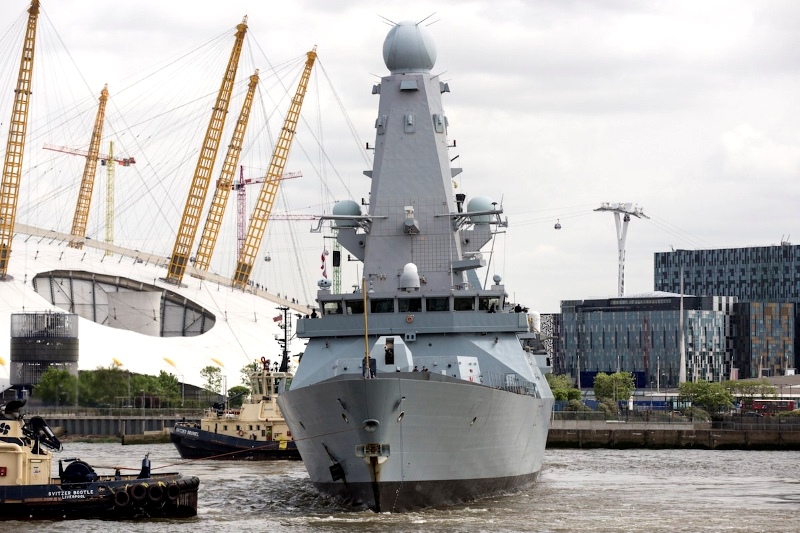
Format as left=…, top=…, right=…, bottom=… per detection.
left=170, top=307, right=300, bottom=461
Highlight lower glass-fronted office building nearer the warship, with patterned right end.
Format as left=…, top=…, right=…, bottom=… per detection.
left=554, top=292, right=736, bottom=390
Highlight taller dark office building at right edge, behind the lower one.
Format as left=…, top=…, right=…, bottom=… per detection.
left=653, top=242, right=800, bottom=379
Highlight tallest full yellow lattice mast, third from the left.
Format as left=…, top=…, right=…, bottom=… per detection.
left=164, top=16, right=247, bottom=285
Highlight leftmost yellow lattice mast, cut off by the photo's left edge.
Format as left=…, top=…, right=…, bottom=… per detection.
left=0, top=0, right=39, bottom=279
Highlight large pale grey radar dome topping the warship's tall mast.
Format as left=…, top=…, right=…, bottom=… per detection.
left=383, top=20, right=436, bottom=74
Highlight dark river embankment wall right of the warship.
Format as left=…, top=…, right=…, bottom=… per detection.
left=547, top=420, right=800, bottom=450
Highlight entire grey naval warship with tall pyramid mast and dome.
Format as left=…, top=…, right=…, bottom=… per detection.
left=278, top=22, right=553, bottom=512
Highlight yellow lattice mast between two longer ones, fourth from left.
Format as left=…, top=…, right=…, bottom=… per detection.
left=194, top=70, right=258, bottom=270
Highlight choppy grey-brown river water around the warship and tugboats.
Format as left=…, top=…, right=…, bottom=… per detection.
left=0, top=443, right=800, bottom=533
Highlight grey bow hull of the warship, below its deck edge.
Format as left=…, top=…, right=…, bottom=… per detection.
left=278, top=372, right=553, bottom=512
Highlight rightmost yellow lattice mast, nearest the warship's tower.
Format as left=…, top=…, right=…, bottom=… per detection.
left=231, top=46, right=317, bottom=289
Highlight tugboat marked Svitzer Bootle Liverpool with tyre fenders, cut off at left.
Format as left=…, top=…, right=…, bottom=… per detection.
left=0, top=400, right=200, bottom=520
